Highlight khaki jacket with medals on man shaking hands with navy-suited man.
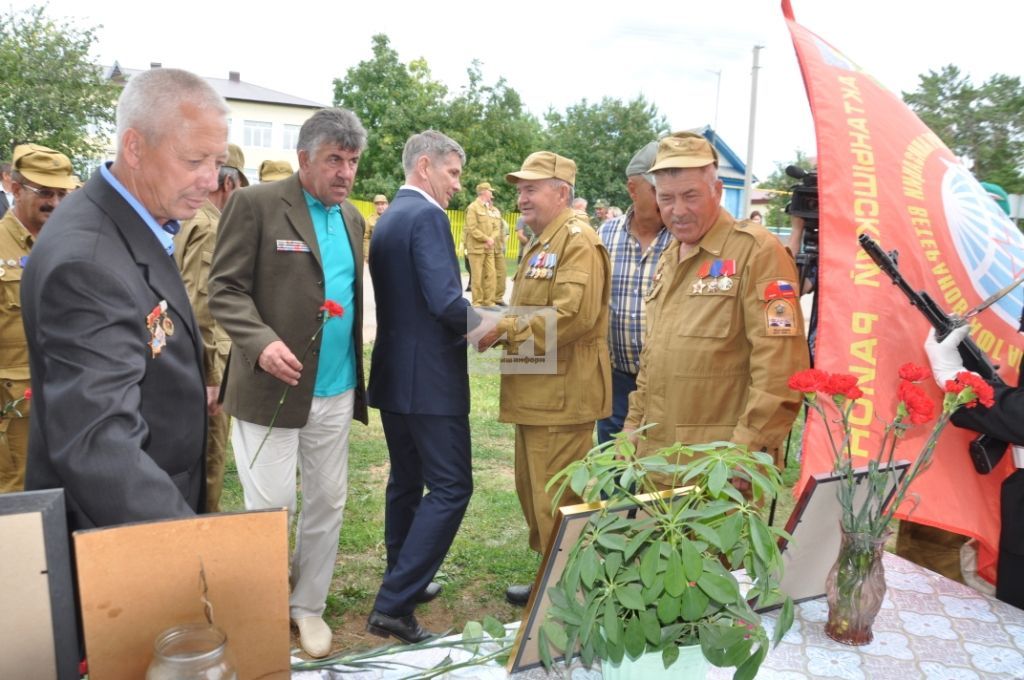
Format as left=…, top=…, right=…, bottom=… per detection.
left=499, top=209, right=611, bottom=425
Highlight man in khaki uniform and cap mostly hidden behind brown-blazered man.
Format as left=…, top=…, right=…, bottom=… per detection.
left=174, top=144, right=249, bottom=512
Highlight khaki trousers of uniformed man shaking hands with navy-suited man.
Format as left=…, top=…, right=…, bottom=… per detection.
left=515, top=421, right=594, bottom=555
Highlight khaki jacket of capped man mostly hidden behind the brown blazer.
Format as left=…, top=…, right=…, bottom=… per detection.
left=174, top=200, right=231, bottom=385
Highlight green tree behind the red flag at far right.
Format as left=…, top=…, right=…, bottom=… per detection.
left=903, top=65, right=1024, bottom=194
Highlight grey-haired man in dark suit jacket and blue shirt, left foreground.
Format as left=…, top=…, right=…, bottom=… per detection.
left=22, top=69, right=227, bottom=529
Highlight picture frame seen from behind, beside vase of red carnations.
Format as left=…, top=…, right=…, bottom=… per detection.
left=757, top=461, right=910, bottom=611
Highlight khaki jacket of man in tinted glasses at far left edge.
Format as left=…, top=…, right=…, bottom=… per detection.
left=0, top=210, right=35, bottom=418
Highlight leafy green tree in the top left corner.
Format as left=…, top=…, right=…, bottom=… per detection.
left=0, top=7, right=120, bottom=168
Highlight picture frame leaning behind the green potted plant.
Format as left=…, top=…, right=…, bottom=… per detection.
left=507, top=486, right=692, bottom=673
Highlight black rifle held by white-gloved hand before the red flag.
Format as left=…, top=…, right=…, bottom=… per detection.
left=857, top=233, right=1010, bottom=474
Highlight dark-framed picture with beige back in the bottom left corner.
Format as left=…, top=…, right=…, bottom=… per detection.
left=0, top=488, right=80, bottom=680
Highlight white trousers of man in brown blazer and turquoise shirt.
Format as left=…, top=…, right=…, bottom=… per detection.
left=231, top=389, right=355, bottom=619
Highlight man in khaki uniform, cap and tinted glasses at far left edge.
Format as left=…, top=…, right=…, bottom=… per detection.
left=0, top=144, right=75, bottom=493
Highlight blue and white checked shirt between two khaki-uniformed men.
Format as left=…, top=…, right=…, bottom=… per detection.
left=597, top=207, right=672, bottom=375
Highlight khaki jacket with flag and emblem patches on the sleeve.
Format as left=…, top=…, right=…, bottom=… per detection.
left=625, top=210, right=808, bottom=460
